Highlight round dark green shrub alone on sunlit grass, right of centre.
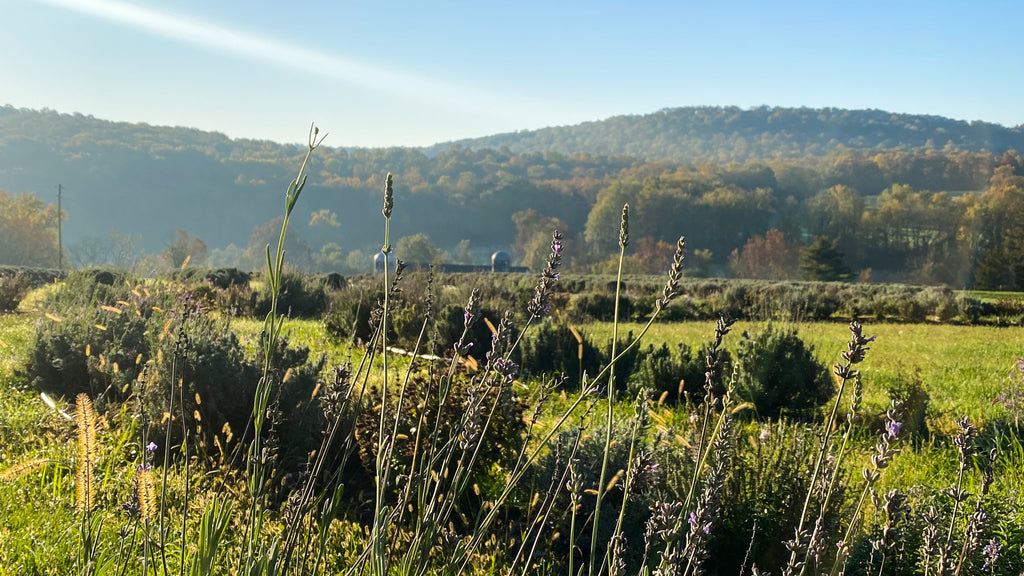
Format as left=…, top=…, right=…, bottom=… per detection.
left=736, top=324, right=834, bottom=418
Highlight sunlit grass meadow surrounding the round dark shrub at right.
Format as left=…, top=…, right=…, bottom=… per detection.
left=580, top=322, right=1024, bottom=427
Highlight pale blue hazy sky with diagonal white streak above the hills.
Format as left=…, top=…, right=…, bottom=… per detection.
left=0, top=0, right=1024, bottom=147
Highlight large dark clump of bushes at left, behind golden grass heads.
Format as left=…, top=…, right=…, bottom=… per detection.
left=26, top=271, right=325, bottom=463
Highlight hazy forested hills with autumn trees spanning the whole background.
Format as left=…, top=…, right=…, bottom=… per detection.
left=6, top=107, right=1024, bottom=289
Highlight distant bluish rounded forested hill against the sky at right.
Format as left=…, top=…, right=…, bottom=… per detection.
left=430, top=107, right=1024, bottom=162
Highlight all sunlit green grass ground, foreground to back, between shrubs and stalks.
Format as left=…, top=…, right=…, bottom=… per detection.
left=0, top=301, right=1024, bottom=576
